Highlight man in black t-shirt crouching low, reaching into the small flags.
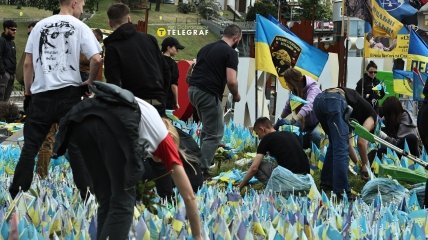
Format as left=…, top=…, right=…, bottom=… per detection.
left=239, top=117, right=310, bottom=188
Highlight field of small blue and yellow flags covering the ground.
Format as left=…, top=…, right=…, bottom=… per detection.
left=0, top=122, right=428, bottom=240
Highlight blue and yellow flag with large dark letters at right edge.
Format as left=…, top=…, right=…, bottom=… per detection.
left=407, top=30, right=428, bottom=73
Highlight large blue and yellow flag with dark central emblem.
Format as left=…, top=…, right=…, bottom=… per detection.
left=255, top=14, right=328, bottom=88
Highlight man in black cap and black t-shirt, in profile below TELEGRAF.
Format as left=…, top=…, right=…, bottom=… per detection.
left=161, top=37, right=184, bottom=109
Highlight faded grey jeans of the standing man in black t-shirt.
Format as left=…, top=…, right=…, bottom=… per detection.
left=188, top=86, right=224, bottom=171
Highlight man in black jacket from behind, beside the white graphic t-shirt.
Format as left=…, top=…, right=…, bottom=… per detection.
left=104, top=3, right=169, bottom=116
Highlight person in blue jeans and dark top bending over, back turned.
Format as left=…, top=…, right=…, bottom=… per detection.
left=314, top=88, right=377, bottom=196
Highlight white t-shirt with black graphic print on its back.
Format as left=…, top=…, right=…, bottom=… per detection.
left=25, top=15, right=102, bottom=94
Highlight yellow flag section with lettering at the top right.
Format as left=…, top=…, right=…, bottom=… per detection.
left=371, top=0, right=403, bottom=39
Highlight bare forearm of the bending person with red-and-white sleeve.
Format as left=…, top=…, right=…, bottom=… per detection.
left=171, top=165, right=202, bottom=239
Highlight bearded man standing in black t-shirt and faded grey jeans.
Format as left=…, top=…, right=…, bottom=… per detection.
left=188, top=24, right=242, bottom=174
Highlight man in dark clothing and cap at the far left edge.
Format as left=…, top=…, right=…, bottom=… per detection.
left=0, top=20, right=17, bottom=101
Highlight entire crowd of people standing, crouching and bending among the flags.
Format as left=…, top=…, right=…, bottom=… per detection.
left=0, top=0, right=428, bottom=239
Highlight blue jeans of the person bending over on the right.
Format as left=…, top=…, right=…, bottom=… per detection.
left=314, top=92, right=349, bottom=195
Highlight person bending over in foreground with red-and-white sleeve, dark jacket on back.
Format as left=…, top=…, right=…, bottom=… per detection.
left=55, top=82, right=202, bottom=239
